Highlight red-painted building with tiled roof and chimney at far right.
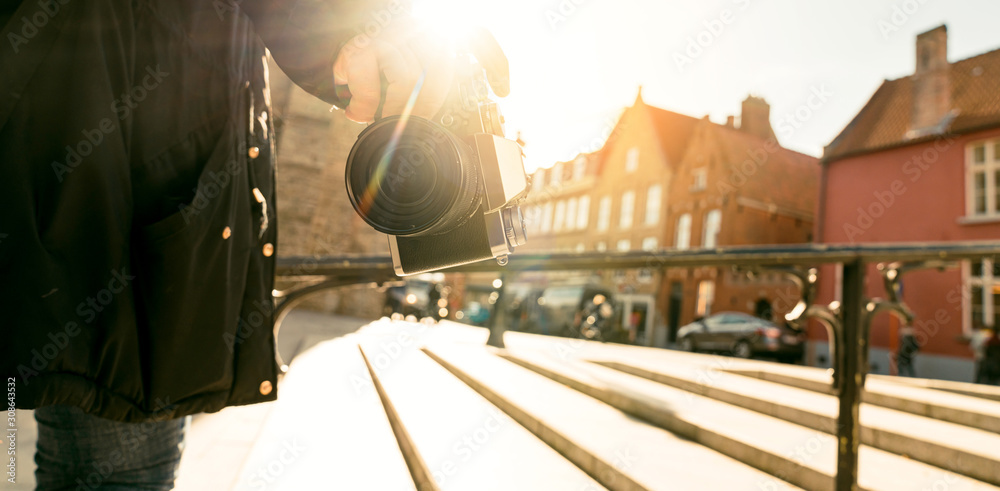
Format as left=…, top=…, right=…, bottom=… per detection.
left=810, top=26, right=1000, bottom=381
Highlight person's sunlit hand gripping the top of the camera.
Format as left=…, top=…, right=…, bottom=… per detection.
left=333, top=19, right=510, bottom=123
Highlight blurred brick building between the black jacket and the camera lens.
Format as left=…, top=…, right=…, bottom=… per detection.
left=270, top=62, right=389, bottom=318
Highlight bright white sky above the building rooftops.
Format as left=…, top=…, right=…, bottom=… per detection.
left=416, top=0, right=1000, bottom=172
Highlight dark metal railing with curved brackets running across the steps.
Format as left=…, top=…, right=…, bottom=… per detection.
left=274, top=242, right=1000, bottom=491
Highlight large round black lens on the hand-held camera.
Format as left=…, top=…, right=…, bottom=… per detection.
left=346, top=116, right=482, bottom=236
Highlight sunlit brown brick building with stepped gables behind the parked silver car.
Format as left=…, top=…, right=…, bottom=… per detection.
left=521, top=90, right=819, bottom=346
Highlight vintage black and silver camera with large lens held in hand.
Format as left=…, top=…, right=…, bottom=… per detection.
left=345, top=57, right=528, bottom=276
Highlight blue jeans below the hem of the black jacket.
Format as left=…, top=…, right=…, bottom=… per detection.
left=35, top=406, right=187, bottom=491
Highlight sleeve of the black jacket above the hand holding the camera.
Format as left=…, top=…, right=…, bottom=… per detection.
left=240, top=0, right=390, bottom=107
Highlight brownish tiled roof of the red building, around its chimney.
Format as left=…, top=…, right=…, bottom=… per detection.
left=823, top=49, right=1000, bottom=162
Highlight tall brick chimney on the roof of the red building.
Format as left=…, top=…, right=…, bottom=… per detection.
left=910, top=25, right=952, bottom=136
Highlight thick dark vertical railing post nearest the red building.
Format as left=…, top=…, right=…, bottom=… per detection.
left=835, top=260, right=868, bottom=491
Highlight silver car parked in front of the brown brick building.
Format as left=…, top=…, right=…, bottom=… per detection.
left=677, top=312, right=805, bottom=362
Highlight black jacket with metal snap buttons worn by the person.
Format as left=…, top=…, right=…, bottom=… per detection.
left=0, top=0, right=373, bottom=421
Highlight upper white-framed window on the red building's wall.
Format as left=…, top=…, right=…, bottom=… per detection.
left=965, top=140, right=1000, bottom=218
